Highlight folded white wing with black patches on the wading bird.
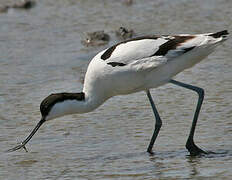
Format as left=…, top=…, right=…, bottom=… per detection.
left=101, top=34, right=207, bottom=70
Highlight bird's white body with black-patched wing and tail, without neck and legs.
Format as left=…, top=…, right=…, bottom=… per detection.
left=84, top=31, right=228, bottom=97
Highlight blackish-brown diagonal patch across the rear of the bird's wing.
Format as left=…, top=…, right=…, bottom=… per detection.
left=151, top=36, right=195, bottom=56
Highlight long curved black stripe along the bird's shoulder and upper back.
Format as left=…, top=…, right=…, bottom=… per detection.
left=101, top=36, right=160, bottom=60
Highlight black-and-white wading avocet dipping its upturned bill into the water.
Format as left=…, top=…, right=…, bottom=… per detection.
left=7, top=30, right=229, bottom=155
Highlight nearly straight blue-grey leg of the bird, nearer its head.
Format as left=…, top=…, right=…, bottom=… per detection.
left=146, top=90, right=162, bottom=154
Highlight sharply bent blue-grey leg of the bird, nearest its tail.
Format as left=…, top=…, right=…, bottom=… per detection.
left=170, top=80, right=206, bottom=156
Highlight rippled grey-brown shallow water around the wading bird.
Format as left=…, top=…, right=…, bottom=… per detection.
left=0, top=0, right=232, bottom=180
